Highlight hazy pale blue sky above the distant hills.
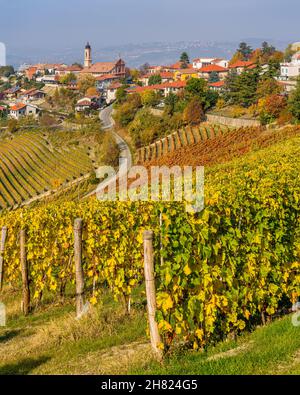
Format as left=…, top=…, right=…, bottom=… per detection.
left=0, top=0, right=300, bottom=50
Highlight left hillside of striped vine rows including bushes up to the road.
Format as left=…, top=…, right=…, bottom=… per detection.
left=0, top=131, right=101, bottom=210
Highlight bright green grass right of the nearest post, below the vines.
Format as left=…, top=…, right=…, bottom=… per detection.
left=130, top=316, right=300, bottom=375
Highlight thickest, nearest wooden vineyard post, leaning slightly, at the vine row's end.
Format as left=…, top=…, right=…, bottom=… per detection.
left=144, top=230, right=162, bottom=359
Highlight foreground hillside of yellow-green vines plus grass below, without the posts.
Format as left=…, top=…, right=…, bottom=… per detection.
left=0, top=132, right=300, bottom=374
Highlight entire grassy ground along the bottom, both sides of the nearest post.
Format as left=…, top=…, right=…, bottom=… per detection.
left=0, top=284, right=300, bottom=375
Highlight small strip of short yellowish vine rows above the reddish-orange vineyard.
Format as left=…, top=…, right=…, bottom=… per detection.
left=137, top=125, right=229, bottom=163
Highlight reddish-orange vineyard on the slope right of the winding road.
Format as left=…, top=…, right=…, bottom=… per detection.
left=139, top=126, right=300, bottom=167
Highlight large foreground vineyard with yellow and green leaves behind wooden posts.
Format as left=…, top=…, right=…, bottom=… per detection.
left=0, top=137, right=300, bottom=349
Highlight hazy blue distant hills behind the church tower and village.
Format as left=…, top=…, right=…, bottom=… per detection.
left=7, top=38, right=289, bottom=67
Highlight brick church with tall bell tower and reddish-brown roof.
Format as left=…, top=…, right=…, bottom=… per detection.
left=80, top=43, right=126, bottom=78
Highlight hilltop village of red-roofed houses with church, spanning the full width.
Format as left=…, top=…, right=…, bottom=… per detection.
left=0, top=43, right=300, bottom=124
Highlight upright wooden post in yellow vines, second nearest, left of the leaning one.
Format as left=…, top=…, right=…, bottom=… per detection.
left=74, top=218, right=84, bottom=318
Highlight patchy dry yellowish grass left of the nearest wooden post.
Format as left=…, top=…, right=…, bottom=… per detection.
left=0, top=291, right=151, bottom=375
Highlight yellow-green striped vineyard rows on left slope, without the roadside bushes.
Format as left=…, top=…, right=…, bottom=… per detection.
left=0, top=132, right=93, bottom=210
